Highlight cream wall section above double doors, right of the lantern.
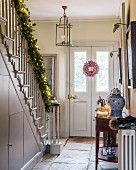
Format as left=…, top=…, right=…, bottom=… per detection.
left=72, top=20, right=120, bottom=42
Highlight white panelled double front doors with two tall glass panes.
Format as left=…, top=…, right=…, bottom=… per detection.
left=69, top=46, right=118, bottom=137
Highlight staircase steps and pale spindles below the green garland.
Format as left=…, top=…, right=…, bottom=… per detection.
left=0, top=1, right=46, bottom=145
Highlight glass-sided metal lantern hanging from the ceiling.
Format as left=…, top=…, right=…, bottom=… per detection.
left=56, top=6, right=72, bottom=46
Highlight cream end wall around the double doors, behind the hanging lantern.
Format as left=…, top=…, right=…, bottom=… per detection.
left=34, top=20, right=120, bottom=136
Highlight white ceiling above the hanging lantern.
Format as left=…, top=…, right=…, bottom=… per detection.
left=25, top=0, right=125, bottom=20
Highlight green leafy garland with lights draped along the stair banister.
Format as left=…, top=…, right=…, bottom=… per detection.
left=14, top=0, right=51, bottom=110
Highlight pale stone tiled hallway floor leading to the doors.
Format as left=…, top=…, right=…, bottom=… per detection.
left=33, top=138, right=118, bottom=170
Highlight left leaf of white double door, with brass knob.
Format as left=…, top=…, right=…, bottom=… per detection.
left=70, top=48, right=91, bottom=136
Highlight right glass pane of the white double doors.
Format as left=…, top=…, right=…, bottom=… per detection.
left=96, top=51, right=109, bottom=92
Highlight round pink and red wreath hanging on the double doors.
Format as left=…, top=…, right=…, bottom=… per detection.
left=83, top=61, right=99, bottom=77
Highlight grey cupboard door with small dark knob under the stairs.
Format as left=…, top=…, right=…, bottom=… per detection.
left=9, top=112, right=23, bottom=170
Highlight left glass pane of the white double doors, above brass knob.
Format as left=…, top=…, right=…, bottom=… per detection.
left=74, top=52, right=86, bottom=92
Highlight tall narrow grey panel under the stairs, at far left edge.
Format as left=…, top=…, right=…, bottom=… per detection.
left=0, top=55, right=9, bottom=170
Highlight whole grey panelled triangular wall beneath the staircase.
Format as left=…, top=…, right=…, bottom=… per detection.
left=0, top=54, right=40, bottom=170
